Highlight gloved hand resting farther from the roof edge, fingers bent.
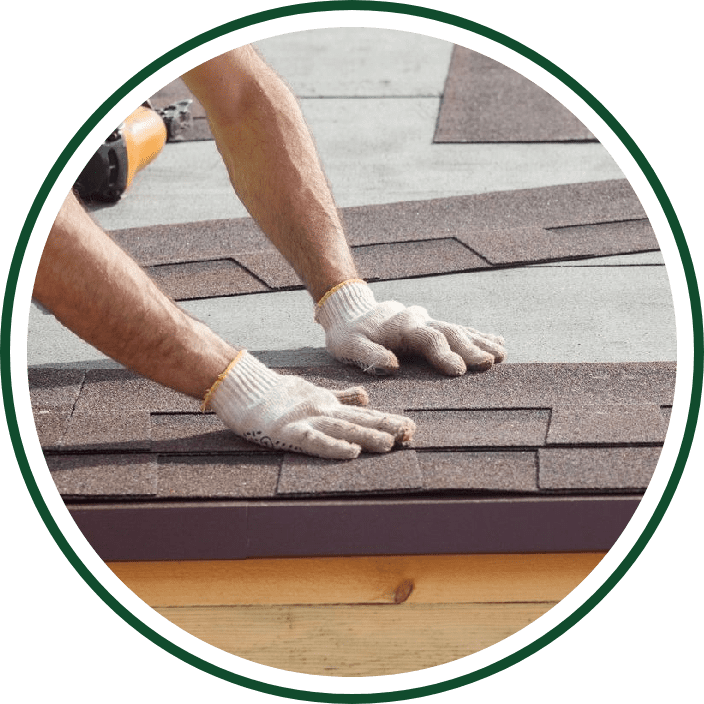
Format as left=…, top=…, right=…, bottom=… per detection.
left=315, top=279, right=506, bottom=376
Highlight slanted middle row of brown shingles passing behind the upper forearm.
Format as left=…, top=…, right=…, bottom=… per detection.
left=112, top=180, right=659, bottom=300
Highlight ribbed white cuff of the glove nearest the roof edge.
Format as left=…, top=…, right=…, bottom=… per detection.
left=203, top=350, right=279, bottom=417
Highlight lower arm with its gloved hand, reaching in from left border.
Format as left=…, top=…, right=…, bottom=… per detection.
left=33, top=193, right=414, bottom=459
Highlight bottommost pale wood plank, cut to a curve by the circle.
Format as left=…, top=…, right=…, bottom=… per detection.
left=157, top=603, right=555, bottom=677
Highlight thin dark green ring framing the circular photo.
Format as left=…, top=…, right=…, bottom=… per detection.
left=8, top=2, right=704, bottom=702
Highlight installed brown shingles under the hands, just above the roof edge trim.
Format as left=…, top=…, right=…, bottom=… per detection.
left=31, top=362, right=676, bottom=499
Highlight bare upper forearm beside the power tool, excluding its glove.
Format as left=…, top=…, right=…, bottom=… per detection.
left=183, top=47, right=357, bottom=300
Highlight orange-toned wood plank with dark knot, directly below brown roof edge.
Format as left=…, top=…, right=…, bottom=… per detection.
left=107, top=553, right=604, bottom=607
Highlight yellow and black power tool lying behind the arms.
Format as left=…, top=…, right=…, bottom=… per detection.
left=74, top=100, right=193, bottom=203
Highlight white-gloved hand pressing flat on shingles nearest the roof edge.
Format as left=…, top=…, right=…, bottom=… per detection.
left=204, top=351, right=415, bottom=459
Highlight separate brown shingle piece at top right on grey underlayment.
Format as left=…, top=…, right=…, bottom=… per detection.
left=434, top=46, right=595, bottom=142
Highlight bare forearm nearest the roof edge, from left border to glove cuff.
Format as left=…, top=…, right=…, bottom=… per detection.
left=34, top=193, right=236, bottom=398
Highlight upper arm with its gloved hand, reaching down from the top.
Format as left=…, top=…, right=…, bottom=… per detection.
left=183, top=46, right=506, bottom=375
